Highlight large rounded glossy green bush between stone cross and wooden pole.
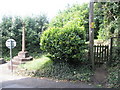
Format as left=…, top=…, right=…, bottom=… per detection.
left=40, top=21, right=85, bottom=62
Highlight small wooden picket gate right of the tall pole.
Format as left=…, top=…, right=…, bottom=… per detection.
left=94, top=45, right=109, bottom=65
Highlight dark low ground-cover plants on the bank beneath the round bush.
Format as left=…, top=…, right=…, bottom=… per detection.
left=33, top=63, right=92, bottom=82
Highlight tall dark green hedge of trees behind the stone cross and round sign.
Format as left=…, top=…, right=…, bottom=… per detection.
left=0, top=15, right=48, bottom=56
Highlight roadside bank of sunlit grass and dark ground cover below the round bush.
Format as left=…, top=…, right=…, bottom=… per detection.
left=16, top=55, right=93, bottom=82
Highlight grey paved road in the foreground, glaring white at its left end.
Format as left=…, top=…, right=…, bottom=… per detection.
left=0, top=64, right=94, bottom=88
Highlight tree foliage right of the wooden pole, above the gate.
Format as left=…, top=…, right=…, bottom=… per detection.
left=97, top=2, right=120, bottom=40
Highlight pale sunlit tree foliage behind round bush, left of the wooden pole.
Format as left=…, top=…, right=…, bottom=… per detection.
left=49, top=4, right=89, bottom=39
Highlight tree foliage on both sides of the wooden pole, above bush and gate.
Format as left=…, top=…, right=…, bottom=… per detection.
left=49, top=2, right=120, bottom=40
